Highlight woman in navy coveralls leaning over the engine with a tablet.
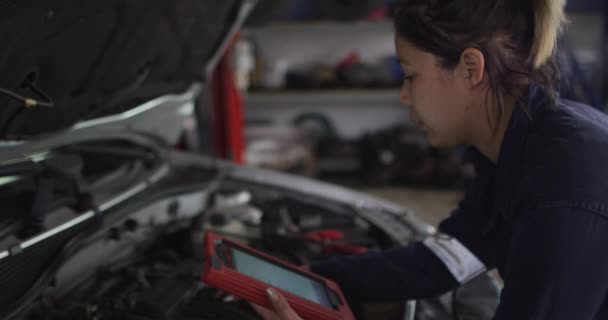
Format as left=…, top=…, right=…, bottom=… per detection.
left=252, top=0, right=608, bottom=320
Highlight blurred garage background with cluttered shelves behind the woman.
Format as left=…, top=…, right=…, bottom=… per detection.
left=233, top=1, right=608, bottom=225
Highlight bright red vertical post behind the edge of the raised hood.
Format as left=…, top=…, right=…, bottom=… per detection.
left=211, top=35, right=245, bottom=164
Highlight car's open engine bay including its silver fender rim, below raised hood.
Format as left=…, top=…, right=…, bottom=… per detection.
left=0, top=141, right=497, bottom=320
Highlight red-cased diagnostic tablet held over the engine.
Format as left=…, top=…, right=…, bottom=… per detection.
left=202, top=232, right=354, bottom=320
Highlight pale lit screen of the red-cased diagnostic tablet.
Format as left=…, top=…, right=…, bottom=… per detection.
left=230, top=246, right=333, bottom=308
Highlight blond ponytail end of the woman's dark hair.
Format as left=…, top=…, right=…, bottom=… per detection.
left=529, top=0, right=566, bottom=69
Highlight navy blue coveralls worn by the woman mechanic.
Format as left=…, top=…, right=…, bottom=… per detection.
left=311, top=87, right=608, bottom=320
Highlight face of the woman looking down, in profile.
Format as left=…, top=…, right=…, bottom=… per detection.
left=395, top=36, right=474, bottom=147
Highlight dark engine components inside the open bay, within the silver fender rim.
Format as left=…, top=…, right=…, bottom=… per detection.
left=17, top=182, right=394, bottom=320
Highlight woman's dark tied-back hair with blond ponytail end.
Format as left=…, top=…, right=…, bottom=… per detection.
left=395, top=0, right=565, bottom=129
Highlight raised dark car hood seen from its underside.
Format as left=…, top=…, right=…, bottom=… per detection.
left=0, top=0, right=255, bottom=140
